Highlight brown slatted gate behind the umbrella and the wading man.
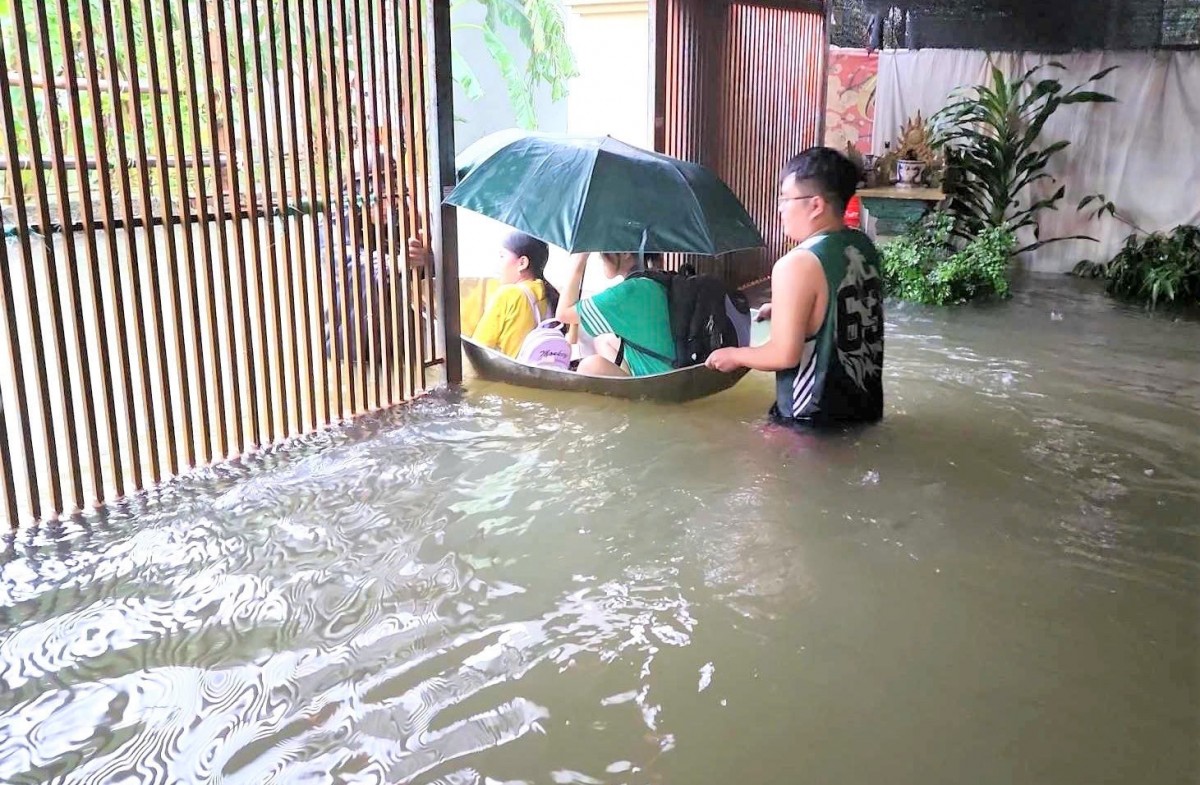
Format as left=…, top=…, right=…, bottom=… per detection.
left=653, top=0, right=829, bottom=286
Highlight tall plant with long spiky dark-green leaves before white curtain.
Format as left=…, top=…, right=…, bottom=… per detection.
left=931, top=62, right=1116, bottom=253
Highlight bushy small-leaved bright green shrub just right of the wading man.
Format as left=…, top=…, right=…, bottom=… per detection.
left=881, top=211, right=1015, bottom=305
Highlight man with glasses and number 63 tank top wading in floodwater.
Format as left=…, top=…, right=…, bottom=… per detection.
left=706, top=148, right=883, bottom=425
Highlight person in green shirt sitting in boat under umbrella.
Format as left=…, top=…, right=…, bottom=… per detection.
left=557, top=253, right=674, bottom=376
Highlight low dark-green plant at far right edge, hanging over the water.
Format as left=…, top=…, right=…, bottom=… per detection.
left=1074, top=224, right=1200, bottom=308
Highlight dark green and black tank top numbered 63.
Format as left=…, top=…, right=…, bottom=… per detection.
left=772, top=229, right=883, bottom=424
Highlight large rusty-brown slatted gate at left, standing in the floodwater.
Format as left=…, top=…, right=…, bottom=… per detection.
left=0, top=0, right=444, bottom=523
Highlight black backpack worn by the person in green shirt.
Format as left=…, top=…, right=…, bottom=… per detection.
left=629, top=265, right=750, bottom=368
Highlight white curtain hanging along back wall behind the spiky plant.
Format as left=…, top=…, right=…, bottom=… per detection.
left=872, top=49, right=1200, bottom=272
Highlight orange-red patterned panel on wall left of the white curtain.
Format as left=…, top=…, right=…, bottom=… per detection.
left=826, top=47, right=880, bottom=154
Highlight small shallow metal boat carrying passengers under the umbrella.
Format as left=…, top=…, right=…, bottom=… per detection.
left=462, top=336, right=746, bottom=403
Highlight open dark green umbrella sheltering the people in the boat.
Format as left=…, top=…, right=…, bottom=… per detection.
left=445, top=132, right=764, bottom=256
